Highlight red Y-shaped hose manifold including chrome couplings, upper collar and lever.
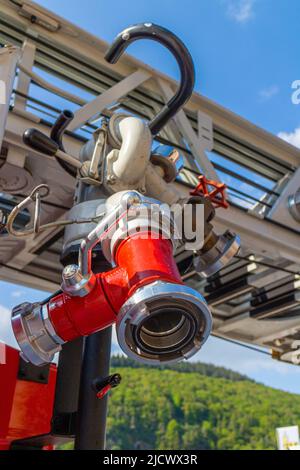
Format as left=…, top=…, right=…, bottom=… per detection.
left=12, top=191, right=212, bottom=365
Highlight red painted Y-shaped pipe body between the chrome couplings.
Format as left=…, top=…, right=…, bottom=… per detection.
left=48, top=233, right=182, bottom=341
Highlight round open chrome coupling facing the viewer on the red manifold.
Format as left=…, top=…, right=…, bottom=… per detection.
left=116, top=281, right=212, bottom=364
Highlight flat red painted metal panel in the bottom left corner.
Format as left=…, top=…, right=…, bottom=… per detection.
left=0, top=346, right=56, bottom=450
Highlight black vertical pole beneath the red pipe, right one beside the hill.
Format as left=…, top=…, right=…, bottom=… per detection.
left=75, top=324, right=112, bottom=450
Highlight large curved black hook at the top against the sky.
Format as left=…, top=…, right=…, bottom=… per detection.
left=104, top=23, right=195, bottom=135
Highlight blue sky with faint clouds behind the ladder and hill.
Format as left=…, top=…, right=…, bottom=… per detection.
left=0, top=0, right=300, bottom=393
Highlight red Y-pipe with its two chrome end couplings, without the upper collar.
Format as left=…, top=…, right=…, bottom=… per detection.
left=12, top=232, right=211, bottom=365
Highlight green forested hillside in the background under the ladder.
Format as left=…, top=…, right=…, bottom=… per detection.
left=107, top=358, right=300, bottom=450
